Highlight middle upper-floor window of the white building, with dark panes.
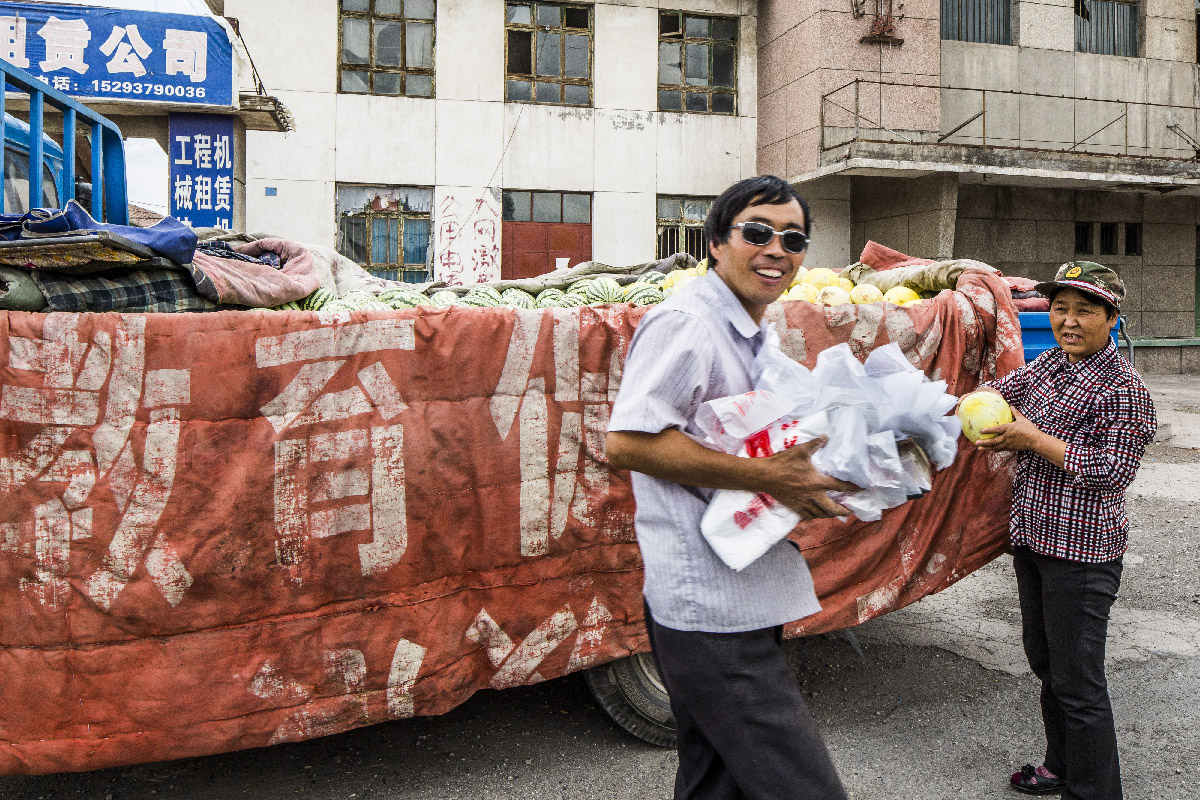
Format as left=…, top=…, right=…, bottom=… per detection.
left=504, top=2, right=592, bottom=106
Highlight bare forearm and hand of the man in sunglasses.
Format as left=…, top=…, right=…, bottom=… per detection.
left=606, top=428, right=858, bottom=519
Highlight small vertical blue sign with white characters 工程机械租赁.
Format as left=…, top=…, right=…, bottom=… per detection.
left=168, top=114, right=234, bottom=230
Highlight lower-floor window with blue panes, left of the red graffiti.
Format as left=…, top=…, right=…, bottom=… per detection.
left=337, top=184, right=433, bottom=283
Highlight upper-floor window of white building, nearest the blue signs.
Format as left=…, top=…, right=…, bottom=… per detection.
left=337, top=0, right=437, bottom=97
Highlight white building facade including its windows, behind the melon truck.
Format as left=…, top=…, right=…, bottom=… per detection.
left=224, top=0, right=758, bottom=283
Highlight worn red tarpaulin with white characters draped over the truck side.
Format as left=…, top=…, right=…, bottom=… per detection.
left=0, top=272, right=1021, bottom=774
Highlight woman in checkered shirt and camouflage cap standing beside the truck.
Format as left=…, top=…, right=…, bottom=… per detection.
left=977, top=261, right=1157, bottom=800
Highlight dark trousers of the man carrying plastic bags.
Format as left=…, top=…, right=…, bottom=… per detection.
left=646, top=609, right=846, bottom=800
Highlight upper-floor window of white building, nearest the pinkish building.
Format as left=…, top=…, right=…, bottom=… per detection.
left=659, top=11, right=738, bottom=114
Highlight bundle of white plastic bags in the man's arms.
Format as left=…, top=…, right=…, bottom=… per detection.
left=697, top=332, right=961, bottom=570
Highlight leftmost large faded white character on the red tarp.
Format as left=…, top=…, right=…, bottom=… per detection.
left=0, top=314, right=192, bottom=610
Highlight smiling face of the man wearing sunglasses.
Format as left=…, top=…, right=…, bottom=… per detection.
left=708, top=199, right=804, bottom=321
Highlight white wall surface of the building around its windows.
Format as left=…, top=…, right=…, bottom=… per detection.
left=226, top=0, right=757, bottom=277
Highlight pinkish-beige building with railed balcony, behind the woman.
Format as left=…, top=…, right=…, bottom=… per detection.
left=758, top=0, right=1200, bottom=369
